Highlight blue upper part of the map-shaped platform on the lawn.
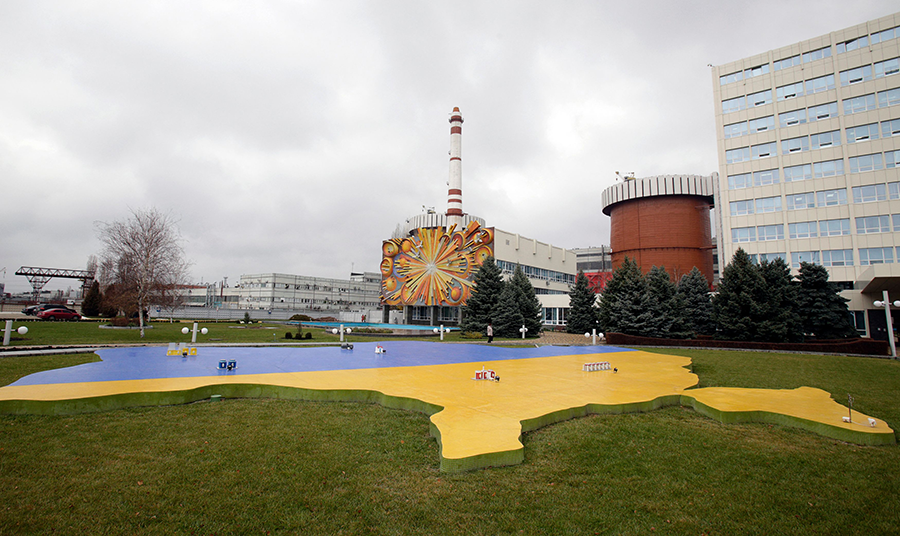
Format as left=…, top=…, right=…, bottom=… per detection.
left=12, top=341, right=632, bottom=385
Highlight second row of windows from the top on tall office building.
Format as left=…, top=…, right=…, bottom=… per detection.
left=722, top=58, right=900, bottom=114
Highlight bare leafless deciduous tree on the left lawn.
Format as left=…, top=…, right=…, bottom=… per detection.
left=97, top=208, right=189, bottom=338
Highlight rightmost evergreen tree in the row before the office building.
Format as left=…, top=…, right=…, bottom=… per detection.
left=797, top=262, right=859, bottom=339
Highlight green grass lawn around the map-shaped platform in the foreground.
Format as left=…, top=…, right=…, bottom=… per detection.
left=0, top=350, right=900, bottom=535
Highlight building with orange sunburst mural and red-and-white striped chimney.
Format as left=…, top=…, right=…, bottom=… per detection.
left=381, top=108, right=577, bottom=326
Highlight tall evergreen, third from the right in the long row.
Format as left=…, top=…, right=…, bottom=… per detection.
left=713, top=248, right=766, bottom=341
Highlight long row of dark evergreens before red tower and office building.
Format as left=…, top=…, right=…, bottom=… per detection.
left=567, top=249, right=858, bottom=342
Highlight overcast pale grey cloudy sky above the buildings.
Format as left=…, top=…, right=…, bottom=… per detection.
left=0, top=0, right=897, bottom=292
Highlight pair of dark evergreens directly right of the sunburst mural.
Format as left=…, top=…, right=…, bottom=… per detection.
left=460, top=257, right=543, bottom=337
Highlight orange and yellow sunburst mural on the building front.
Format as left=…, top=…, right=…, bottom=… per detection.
left=381, top=221, right=494, bottom=305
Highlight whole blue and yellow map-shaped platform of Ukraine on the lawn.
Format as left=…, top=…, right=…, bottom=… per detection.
left=0, top=341, right=895, bottom=471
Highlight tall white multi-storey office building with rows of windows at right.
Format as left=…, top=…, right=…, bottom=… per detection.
left=712, top=13, right=900, bottom=337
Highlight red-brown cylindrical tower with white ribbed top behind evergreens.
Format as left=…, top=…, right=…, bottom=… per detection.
left=602, top=175, right=714, bottom=285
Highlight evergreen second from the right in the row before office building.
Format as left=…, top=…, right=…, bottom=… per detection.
left=757, top=257, right=803, bottom=342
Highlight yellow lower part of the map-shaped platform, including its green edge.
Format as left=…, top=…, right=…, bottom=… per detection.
left=0, top=351, right=894, bottom=471
